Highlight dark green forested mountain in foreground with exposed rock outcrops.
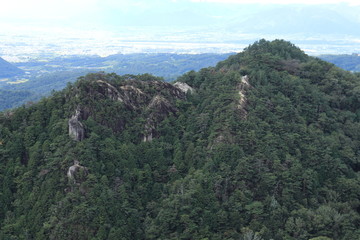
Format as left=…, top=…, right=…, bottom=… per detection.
left=0, top=40, right=360, bottom=240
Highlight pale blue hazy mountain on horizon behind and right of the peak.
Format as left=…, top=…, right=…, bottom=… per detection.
left=229, top=5, right=360, bottom=36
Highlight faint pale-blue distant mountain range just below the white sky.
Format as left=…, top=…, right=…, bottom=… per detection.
left=97, top=3, right=360, bottom=37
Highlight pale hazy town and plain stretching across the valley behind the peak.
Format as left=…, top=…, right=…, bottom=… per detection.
left=0, top=27, right=360, bottom=62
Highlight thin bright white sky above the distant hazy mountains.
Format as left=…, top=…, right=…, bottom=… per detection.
left=0, top=0, right=360, bottom=23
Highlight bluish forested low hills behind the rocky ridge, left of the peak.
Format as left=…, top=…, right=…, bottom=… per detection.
left=0, top=53, right=231, bottom=111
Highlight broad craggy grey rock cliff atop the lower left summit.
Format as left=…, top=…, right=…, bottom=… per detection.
left=69, top=74, right=186, bottom=141
